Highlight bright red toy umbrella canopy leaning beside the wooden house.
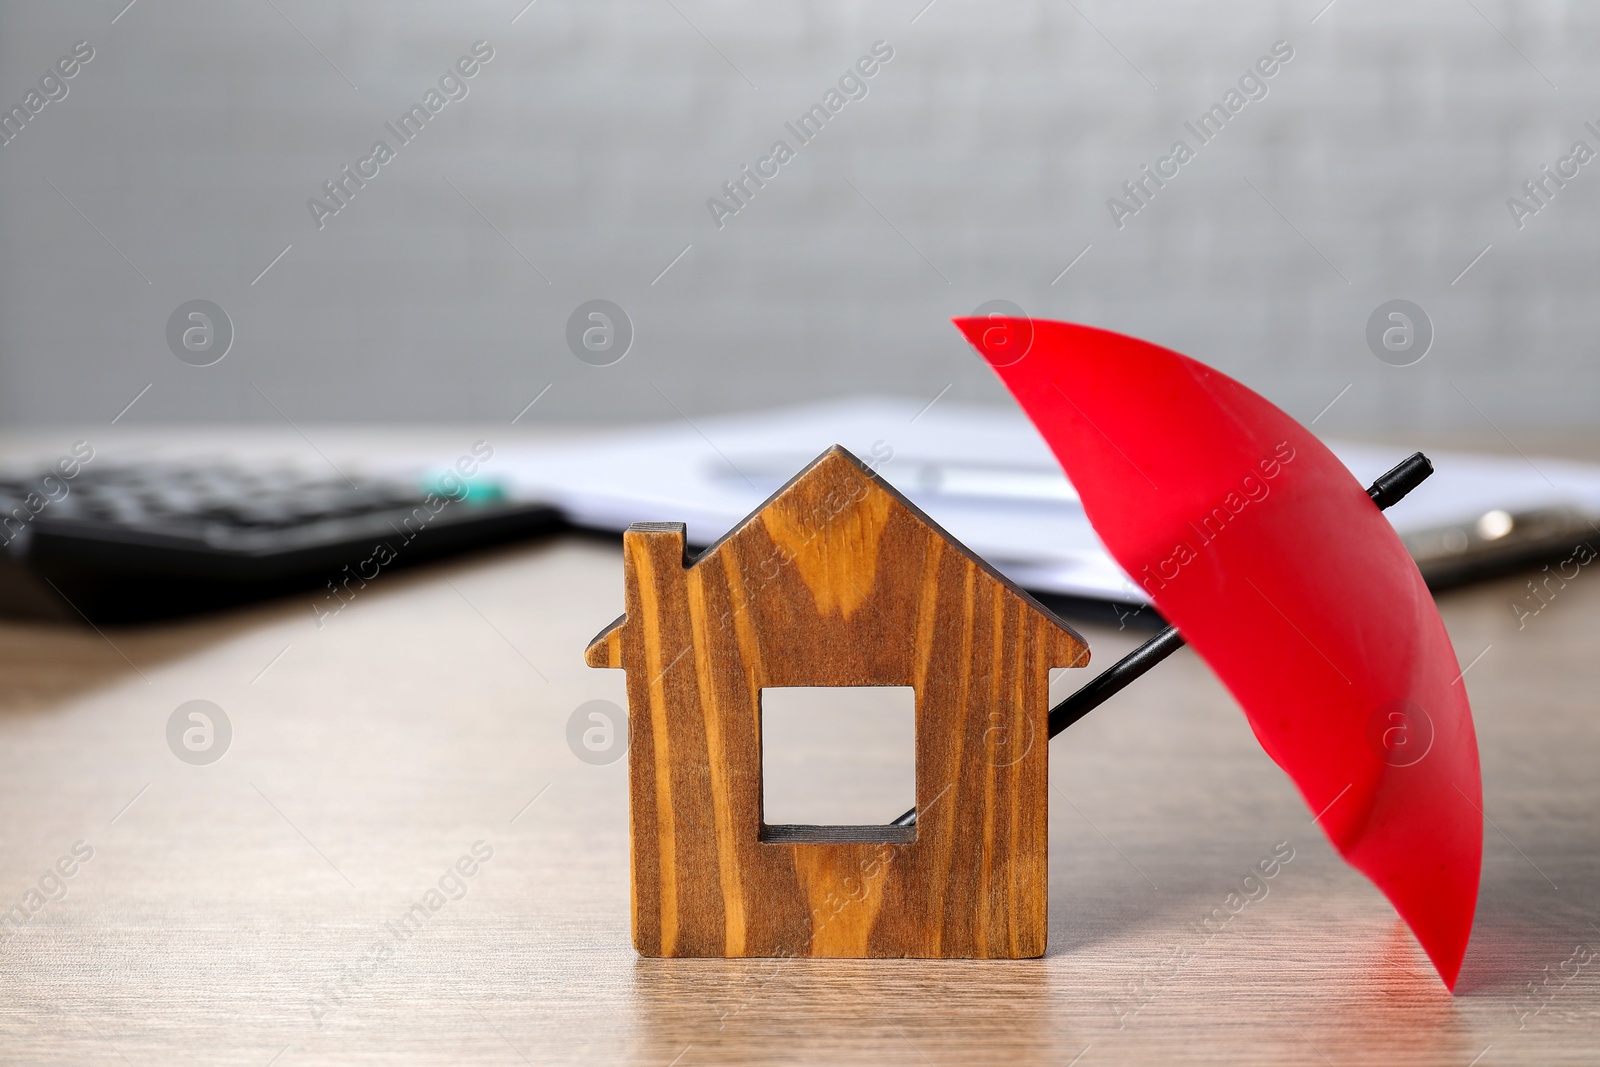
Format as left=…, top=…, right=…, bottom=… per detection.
left=955, top=317, right=1483, bottom=987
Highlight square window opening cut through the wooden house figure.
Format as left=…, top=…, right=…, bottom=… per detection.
left=760, top=685, right=917, bottom=841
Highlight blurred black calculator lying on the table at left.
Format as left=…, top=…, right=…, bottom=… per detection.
left=0, top=461, right=560, bottom=624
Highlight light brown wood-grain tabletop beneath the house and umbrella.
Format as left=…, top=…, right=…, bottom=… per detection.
left=0, top=438, right=1600, bottom=1067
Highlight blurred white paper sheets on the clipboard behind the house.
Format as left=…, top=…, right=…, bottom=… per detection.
left=496, top=397, right=1600, bottom=603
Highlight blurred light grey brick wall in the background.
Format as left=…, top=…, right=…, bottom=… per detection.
left=0, top=0, right=1600, bottom=434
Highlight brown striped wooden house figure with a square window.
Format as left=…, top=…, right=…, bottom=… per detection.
left=586, top=446, right=1088, bottom=958
